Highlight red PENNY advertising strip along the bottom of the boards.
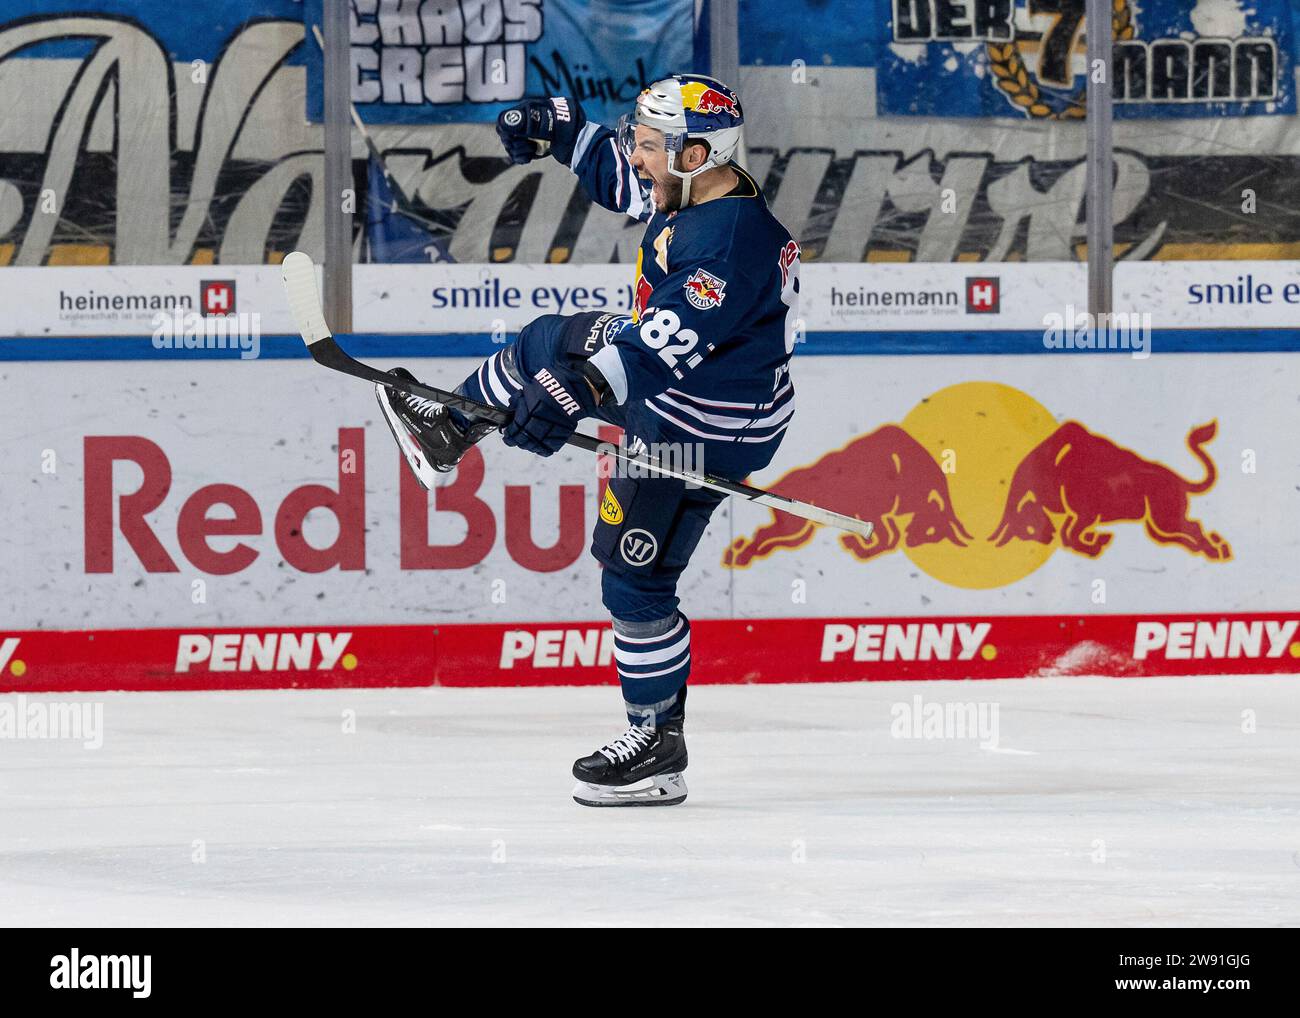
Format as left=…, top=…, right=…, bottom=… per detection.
left=0, top=612, right=1300, bottom=692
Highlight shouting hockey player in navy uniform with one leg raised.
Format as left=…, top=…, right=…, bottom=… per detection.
left=377, top=74, right=800, bottom=806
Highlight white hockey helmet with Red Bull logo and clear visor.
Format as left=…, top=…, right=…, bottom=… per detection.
left=619, top=74, right=745, bottom=208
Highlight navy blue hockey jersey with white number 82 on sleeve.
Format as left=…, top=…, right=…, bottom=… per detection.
left=569, top=124, right=800, bottom=463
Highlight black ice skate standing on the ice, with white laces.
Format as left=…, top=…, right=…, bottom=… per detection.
left=573, top=719, right=686, bottom=806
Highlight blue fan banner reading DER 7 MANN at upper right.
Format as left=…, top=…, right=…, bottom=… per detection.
left=878, top=0, right=1296, bottom=121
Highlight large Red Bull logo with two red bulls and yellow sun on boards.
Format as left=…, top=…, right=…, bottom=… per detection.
left=723, top=382, right=1232, bottom=589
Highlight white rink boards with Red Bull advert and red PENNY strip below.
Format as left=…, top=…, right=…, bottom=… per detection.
left=0, top=335, right=1300, bottom=689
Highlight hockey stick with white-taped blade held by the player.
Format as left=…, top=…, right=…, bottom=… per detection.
left=282, top=251, right=871, bottom=538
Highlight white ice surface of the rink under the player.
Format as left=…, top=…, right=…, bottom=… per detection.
left=0, top=677, right=1300, bottom=926
